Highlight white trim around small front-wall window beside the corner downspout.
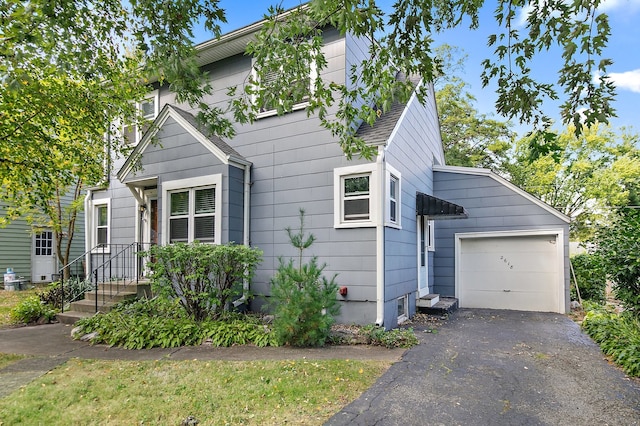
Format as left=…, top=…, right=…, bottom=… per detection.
left=333, top=163, right=379, bottom=228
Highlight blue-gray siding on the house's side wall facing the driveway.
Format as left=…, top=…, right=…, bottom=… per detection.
left=384, top=85, right=444, bottom=328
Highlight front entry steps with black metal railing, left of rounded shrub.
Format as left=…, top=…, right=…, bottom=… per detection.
left=56, top=280, right=151, bottom=324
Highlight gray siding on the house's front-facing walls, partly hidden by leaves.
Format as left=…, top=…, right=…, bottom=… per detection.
left=99, top=31, right=376, bottom=323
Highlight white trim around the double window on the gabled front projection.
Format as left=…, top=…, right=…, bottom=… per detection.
left=160, top=174, right=222, bottom=245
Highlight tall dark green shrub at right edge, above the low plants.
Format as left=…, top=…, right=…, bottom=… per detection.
left=594, top=209, right=640, bottom=315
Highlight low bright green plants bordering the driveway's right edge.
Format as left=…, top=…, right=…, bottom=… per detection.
left=582, top=307, right=640, bottom=377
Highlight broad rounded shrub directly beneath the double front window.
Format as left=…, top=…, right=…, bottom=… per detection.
left=146, top=242, right=262, bottom=321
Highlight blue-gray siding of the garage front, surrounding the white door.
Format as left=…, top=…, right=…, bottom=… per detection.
left=434, top=171, right=570, bottom=303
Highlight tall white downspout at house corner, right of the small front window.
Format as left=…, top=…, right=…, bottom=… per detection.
left=376, top=147, right=386, bottom=327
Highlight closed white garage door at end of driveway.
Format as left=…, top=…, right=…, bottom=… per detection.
left=456, top=234, right=564, bottom=312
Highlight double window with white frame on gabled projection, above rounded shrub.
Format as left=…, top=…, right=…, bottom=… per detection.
left=162, top=175, right=222, bottom=244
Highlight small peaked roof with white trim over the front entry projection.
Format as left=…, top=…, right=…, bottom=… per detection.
left=117, top=104, right=251, bottom=182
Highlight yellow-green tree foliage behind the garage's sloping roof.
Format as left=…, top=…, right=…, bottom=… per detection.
left=506, top=125, right=640, bottom=239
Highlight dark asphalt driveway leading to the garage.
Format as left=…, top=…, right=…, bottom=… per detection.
left=327, top=309, right=640, bottom=426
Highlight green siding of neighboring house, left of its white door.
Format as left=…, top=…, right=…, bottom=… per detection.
left=0, top=205, right=32, bottom=280
